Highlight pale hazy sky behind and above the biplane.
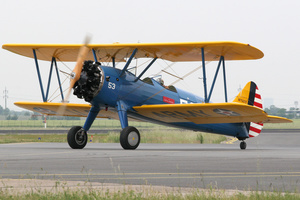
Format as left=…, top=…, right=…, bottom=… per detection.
left=0, top=0, right=300, bottom=110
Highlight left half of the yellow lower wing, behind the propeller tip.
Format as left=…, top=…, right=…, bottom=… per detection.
left=15, top=102, right=118, bottom=119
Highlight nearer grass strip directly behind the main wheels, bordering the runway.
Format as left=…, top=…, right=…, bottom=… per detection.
left=0, top=129, right=226, bottom=144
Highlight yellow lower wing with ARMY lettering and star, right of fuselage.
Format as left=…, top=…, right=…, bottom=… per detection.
left=133, top=103, right=268, bottom=124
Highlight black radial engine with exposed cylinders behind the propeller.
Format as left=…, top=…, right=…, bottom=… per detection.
left=73, top=60, right=103, bottom=102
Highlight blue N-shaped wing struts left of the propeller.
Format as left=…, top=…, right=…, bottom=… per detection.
left=32, top=49, right=64, bottom=102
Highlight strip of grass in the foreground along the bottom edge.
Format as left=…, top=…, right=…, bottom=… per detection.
left=0, top=188, right=300, bottom=200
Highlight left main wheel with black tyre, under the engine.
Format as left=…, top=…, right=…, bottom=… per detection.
left=67, top=126, right=88, bottom=149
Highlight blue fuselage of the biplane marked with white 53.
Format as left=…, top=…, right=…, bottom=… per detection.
left=91, top=66, right=249, bottom=138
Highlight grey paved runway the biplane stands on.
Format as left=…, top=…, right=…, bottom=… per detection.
left=0, top=131, right=300, bottom=192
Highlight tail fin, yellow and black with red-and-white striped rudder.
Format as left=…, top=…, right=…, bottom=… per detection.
left=233, top=81, right=263, bottom=137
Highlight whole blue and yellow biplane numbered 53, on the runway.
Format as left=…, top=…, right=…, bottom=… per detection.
left=2, top=41, right=291, bottom=149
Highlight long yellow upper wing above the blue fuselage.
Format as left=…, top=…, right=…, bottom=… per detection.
left=2, top=41, right=264, bottom=62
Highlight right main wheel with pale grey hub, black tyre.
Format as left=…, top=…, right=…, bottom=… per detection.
left=120, top=126, right=141, bottom=149
